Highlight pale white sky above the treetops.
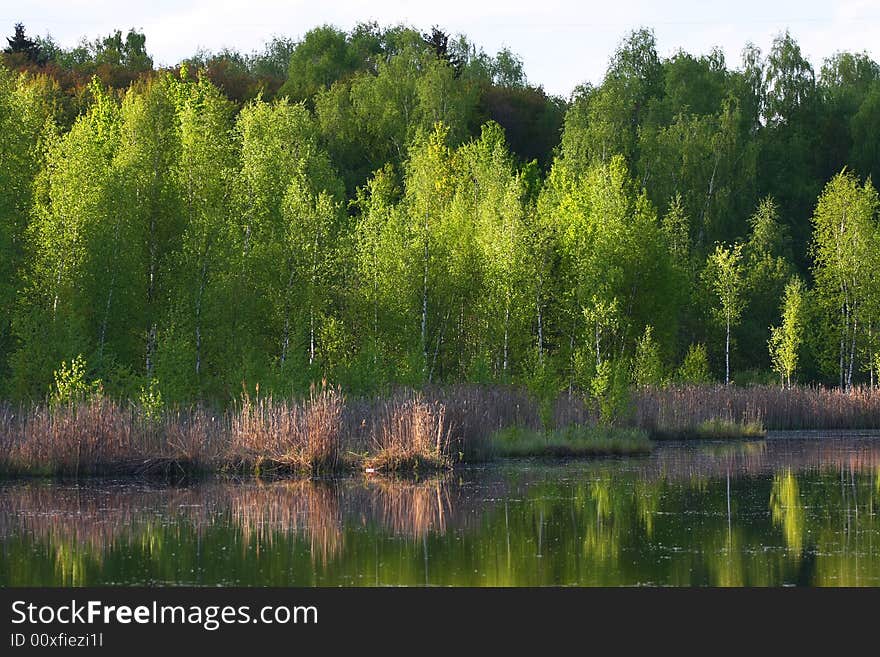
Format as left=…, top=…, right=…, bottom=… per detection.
left=0, top=0, right=880, bottom=97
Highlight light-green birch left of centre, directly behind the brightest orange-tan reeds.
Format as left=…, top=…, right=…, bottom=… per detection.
left=232, top=95, right=342, bottom=384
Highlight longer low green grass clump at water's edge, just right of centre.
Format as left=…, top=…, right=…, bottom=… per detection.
left=491, top=424, right=651, bottom=457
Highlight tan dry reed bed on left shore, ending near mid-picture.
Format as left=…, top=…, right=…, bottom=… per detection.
left=0, top=386, right=451, bottom=477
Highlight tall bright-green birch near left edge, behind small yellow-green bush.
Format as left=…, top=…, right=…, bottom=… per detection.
left=15, top=81, right=122, bottom=393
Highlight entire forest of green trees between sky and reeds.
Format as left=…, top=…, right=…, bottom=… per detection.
left=0, top=25, right=880, bottom=400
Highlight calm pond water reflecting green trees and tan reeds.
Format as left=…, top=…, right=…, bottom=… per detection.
left=0, top=437, right=880, bottom=586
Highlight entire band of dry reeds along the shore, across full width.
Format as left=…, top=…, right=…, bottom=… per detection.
left=0, top=384, right=880, bottom=477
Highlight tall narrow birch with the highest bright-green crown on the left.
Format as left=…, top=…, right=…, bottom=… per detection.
left=163, top=70, right=239, bottom=395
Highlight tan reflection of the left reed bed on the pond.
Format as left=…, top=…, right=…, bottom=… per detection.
left=0, top=478, right=453, bottom=564
